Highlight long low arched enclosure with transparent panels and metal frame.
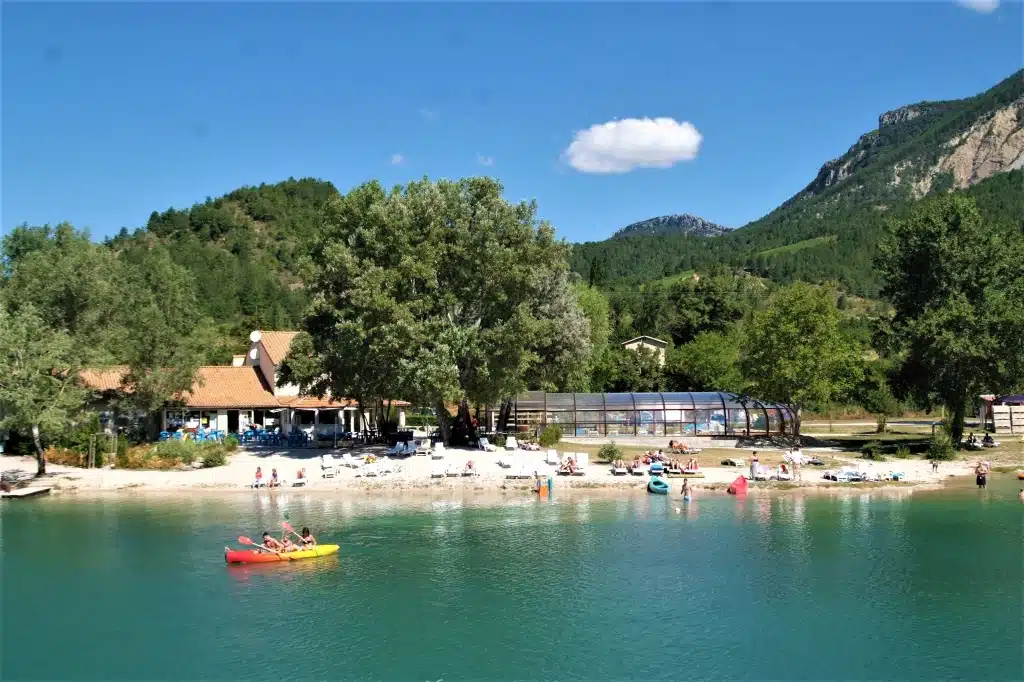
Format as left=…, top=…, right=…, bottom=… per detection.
left=499, top=391, right=794, bottom=438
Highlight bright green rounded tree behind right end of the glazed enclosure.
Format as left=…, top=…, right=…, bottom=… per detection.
left=741, top=283, right=862, bottom=438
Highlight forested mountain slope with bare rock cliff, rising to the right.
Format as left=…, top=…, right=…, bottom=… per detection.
left=572, top=70, right=1024, bottom=295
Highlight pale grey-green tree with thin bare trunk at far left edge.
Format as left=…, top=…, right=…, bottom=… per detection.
left=0, top=303, right=86, bottom=476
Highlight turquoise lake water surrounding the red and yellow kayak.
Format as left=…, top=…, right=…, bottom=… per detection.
left=0, top=476, right=1024, bottom=681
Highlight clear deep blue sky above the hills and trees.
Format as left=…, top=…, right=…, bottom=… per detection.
left=2, top=0, right=1022, bottom=241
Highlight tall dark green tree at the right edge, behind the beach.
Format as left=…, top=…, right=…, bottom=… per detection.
left=879, top=196, right=1024, bottom=442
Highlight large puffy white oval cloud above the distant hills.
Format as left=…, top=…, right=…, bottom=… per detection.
left=562, top=118, right=703, bottom=173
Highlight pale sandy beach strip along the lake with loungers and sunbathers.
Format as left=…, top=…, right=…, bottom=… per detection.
left=0, top=445, right=997, bottom=493
